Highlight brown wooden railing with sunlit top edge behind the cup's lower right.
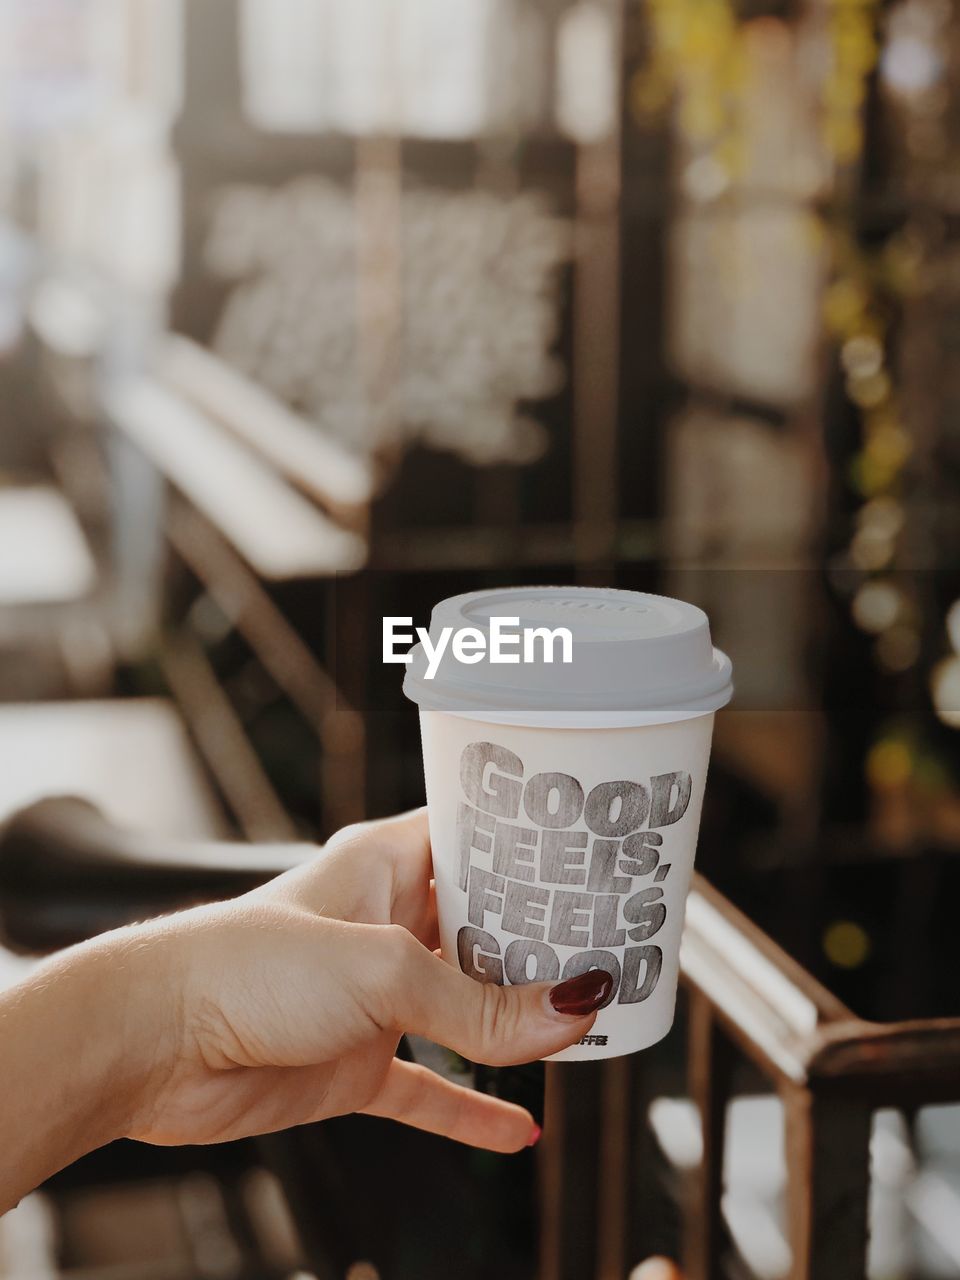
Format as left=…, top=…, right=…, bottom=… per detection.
left=540, top=877, right=960, bottom=1280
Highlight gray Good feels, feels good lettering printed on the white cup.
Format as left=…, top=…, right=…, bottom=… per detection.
left=457, top=742, right=692, bottom=1005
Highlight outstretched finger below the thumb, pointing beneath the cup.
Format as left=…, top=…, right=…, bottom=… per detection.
left=364, top=1059, right=539, bottom=1151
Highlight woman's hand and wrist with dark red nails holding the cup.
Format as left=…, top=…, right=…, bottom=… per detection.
left=0, top=810, right=611, bottom=1208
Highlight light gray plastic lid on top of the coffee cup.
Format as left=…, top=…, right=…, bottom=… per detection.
left=403, top=586, right=733, bottom=727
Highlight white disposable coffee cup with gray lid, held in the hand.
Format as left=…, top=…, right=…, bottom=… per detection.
left=403, top=588, right=732, bottom=1062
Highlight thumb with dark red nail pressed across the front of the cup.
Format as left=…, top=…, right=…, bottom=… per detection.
left=378, top=934, right=613, bottom=1066
